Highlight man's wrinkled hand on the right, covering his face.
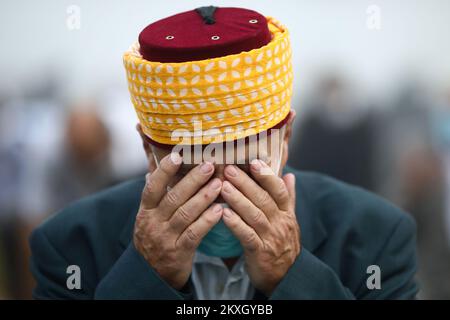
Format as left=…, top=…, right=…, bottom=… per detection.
left=221, top=160, right=301, bottom=296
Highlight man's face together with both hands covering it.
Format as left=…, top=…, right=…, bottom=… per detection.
left=134, top=112, right=301, bottom=293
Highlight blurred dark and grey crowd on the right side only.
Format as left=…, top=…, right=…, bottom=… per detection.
left=290, top=75, right=450, bottom=299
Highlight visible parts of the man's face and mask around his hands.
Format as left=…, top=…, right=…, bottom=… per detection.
left=138, top=110, right=294, bottom=258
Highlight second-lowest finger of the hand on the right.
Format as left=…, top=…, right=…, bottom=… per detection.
left=221, top=181, right=270, bottom=236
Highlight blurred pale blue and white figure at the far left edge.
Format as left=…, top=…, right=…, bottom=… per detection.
left=0, top=73, right=61, bottom=298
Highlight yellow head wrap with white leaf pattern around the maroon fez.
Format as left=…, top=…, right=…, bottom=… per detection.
left=123, top=17, right=293, bottom=145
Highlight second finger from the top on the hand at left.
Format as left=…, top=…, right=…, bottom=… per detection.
left=159, top=162, right=214, bottom=220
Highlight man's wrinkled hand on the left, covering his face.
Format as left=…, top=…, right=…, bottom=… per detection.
left=133, top=153, right=223, bottom=290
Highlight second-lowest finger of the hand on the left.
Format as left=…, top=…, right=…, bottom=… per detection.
left=169, top=178, right=222, bottom=234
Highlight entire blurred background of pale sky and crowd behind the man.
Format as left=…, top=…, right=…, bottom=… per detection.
left=0, top=0, right=450, bottom=299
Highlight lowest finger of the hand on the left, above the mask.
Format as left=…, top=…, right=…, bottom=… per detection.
left=176, top=204, right=223, bottom=250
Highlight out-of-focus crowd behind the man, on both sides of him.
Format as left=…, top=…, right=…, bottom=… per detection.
left=0, top=74, right=450, bottom=299
